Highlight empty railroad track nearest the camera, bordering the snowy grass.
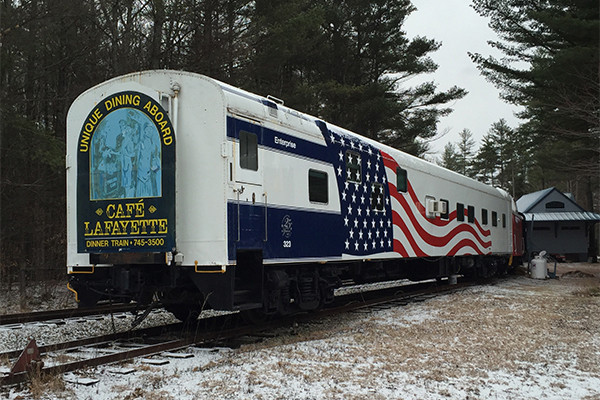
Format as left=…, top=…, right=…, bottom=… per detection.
left=0, top=276, right=488, bottom=386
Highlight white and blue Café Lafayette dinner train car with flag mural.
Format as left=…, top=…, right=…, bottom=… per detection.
left=66, top=70, right=523, bottom=319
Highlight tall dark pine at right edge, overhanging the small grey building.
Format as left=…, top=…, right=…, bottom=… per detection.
left=471, top=0, right=600, bottom=208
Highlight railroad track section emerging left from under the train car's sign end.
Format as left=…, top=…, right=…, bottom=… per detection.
left=0, top=304, right=137, bottom=325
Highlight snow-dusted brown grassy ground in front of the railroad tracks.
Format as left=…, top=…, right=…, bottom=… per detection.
left=0, top=264, right=600, bottom=400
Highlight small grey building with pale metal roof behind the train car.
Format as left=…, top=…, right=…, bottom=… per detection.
left=517, top=187, right=600, bottom=261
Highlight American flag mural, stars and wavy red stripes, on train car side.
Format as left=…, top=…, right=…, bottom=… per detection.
left=325, top=128, right=492, bottom=257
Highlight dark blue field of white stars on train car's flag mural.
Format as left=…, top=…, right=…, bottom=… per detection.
left=325, top=129, right=394, bottom=256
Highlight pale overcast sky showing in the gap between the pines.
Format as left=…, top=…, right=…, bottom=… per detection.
left=404, top=0, right=520, bottom=156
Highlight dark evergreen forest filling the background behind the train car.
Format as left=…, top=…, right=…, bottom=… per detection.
left=0, top=0, right=600, bottom=283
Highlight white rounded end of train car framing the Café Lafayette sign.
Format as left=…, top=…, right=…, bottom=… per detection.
left=67, top=71, right=227, bottom=266
